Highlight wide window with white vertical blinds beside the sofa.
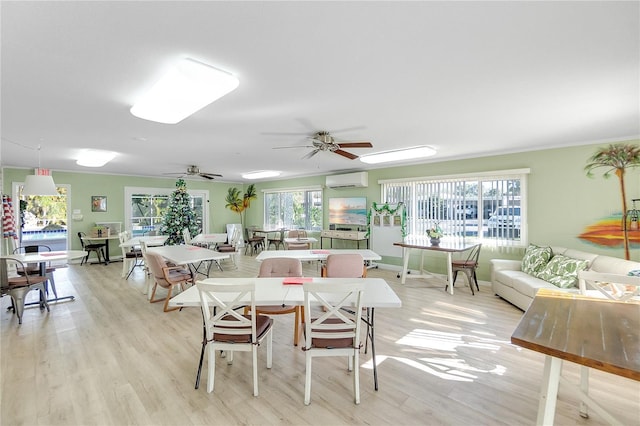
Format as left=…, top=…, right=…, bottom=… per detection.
left=379, top=169, right=529, bottom=246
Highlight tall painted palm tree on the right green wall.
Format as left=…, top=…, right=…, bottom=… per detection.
left=584, top=144, right=640, bottom=260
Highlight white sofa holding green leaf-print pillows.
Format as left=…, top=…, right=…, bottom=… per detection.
left=490, top=247, right=640, bottom=310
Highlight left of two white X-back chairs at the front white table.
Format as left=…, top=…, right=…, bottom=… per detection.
left=196, top=281, right=273, bottom=396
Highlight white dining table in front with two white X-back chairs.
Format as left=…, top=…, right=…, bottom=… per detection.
left=169, top=278, right=402, bottom=390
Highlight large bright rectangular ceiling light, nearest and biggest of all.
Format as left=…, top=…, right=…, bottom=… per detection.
left=131, top=58, right=239, bottom=124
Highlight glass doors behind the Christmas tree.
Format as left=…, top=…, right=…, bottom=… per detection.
left=125, top=187, right=209, bottom=236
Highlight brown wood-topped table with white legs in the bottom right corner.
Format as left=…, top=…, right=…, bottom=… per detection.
left=511, top=289, right=640, bottom=425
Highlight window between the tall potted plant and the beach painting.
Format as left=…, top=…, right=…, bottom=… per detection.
left=264, top=188, right=322, bottom=231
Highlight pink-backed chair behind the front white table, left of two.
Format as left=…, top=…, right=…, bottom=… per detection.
left=244, top=257, right=304, bottom=346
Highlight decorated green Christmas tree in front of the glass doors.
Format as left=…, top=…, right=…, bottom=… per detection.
left=160, top=179, right=199, bottom=245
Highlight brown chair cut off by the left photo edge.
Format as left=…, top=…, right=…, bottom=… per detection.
left=0, top=257, right=49, bottom=324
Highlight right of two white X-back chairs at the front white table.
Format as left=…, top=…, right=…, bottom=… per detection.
left=303, top=281, right=364, bottom=405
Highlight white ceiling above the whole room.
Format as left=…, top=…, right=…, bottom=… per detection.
left=0, top=1, right=640, bottom=182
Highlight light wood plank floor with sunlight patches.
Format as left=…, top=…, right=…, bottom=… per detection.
left=0, top=251, right=640, bottom=426
